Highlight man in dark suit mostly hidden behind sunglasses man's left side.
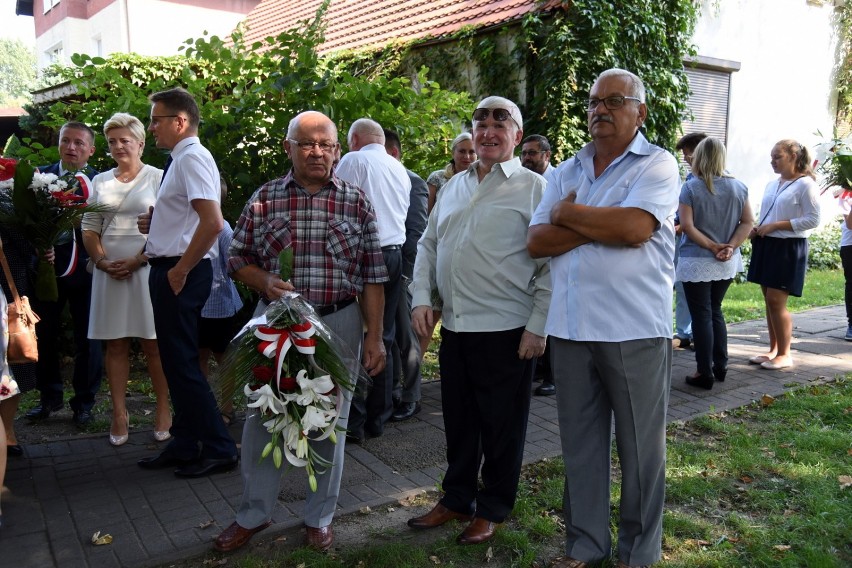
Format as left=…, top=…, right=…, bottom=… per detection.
left=385, top=129, right=429, bottom=422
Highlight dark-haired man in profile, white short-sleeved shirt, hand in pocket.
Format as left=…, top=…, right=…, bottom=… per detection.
left=138, top=89, right=238, bottom=477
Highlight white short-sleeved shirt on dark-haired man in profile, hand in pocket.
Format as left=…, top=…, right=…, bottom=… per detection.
left=145, top=136, right=221, bottom=258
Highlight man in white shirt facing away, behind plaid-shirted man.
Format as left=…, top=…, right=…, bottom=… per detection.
left=335, top=118, right=411, bottom=443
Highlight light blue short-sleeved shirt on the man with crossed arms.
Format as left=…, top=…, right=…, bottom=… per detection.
left=530, top=133, right=680, bottom=342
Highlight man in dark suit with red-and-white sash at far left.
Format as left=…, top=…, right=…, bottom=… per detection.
left=26, top=122, right=103, bottom=426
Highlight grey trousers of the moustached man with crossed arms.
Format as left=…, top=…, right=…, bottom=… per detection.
left=551, top=337, right=672, bottom=565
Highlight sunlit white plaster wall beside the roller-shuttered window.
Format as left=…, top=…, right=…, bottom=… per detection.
left=694, top=0, right=837, bottom=215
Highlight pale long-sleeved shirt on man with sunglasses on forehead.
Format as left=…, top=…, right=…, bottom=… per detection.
left=411, top=158, right=550, bottom=336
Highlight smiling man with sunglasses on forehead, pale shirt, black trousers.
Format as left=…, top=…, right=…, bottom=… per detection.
left=408, top=97, right=550, bottom=544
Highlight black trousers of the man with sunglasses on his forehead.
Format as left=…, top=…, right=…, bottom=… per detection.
left=438, top=327, right=534, bottom=523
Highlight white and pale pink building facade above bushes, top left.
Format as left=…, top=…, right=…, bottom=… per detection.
left=33, top=0, right=260, bottom=67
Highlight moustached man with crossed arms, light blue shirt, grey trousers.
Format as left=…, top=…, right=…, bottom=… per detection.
left=528, top=69, right=679, bottom=568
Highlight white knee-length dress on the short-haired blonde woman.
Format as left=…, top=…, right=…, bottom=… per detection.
left=83, top=165, right=163, bottom=339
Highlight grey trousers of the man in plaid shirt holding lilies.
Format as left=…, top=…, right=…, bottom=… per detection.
left=236, top=303, right=364, bottom=529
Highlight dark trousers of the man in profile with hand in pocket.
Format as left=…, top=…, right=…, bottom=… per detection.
left=148, top=257, right=237, bottom=459
